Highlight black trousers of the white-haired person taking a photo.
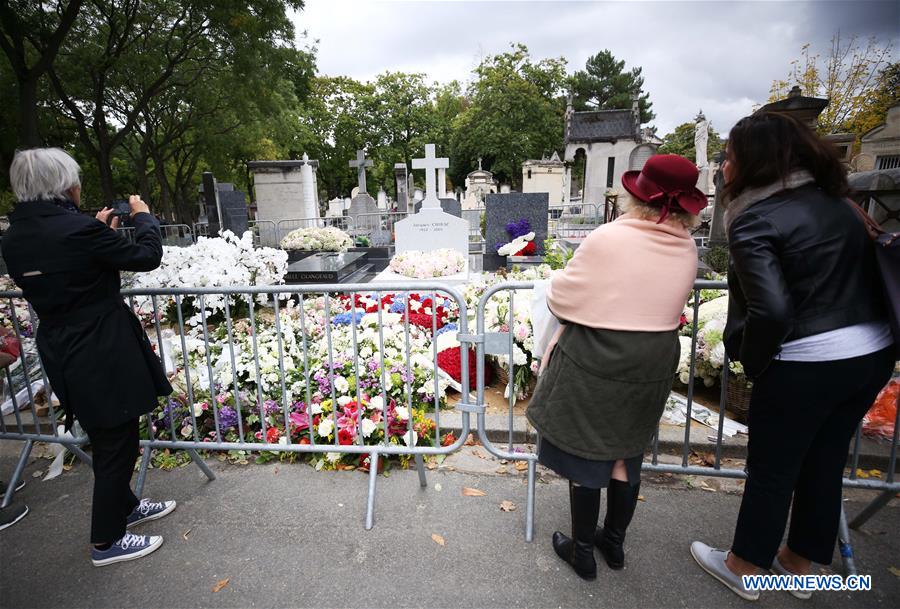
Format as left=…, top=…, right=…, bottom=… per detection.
left=85, top=418, right=140, bottom=544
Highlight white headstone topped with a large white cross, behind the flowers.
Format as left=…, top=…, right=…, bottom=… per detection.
left=395, top=144, right=469, bottom=269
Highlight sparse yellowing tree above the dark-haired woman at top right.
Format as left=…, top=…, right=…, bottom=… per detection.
left=769, top=33, right=893, bottom=135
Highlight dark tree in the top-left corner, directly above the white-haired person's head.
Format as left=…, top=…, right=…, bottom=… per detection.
left=0, top=0, right=83, bottom=148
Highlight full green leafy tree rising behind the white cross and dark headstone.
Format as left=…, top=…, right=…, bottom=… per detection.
left=451, top=44, right=566, bottom=186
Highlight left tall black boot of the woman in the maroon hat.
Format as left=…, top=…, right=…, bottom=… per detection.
left=553, top=482, right=600, bottom=580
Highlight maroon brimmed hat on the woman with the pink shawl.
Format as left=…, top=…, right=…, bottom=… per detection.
left=622, top=154, right=708, bottom=221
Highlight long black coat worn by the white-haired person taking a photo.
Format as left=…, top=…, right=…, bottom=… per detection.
left=2, top=201, right=172, bottom=429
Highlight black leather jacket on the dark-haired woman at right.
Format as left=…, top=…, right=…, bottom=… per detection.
left=725, top=184, right=887, bottom=378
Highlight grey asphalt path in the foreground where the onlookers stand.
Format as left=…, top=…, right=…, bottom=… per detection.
left=0, top=443, right=900, bottom=609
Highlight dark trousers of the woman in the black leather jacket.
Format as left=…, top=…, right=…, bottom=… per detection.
left=731, top=347, right=894, bottom=569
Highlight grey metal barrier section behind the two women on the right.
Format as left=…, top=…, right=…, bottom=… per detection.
left=474, top=280, right=900, bottom=574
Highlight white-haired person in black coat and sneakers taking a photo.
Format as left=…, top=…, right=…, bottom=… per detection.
left=3, top=148, right=175, bottom=566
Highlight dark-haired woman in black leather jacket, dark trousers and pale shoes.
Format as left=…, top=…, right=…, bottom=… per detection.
left=691, top=112, right=895, bottom=599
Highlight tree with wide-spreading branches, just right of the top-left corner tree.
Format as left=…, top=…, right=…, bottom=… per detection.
left=48, top=0, right=302, bottom=200
